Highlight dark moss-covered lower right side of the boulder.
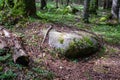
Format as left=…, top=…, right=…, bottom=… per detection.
left=64, top=36, right=99, bottom=58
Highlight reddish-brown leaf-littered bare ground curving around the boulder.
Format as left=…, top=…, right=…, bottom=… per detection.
left=11, top=22, right=120, bottom=80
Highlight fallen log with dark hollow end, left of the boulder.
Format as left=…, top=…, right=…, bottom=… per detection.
left=0, top=26, right=29, bottom=65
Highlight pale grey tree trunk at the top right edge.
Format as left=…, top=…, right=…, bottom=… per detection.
left=111, top=0, right=120, bottom=19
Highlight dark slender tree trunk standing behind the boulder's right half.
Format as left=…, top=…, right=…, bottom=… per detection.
left=83, top=0, right=90, bottom=23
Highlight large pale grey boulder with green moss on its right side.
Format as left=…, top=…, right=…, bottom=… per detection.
left=43, top=30, right=99, bottom=58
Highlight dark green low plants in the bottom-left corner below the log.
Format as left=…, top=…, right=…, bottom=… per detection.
left=0, top=49, right=54, bottom=80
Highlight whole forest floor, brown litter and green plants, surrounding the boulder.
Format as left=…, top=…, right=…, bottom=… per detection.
left=0, top=6, right=120, bottom=80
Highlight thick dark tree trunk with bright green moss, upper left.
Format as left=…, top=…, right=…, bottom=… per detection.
left=5, top=0, right=36, bottom=16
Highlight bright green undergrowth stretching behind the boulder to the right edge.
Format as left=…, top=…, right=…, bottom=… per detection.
left=37, top=4, right=120, bottom=45
